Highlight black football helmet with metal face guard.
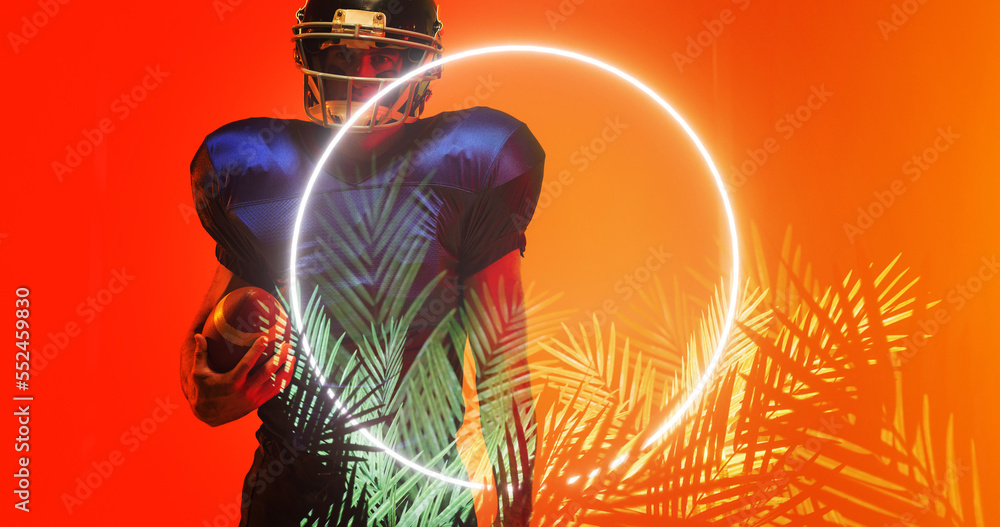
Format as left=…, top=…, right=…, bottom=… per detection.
left=292, top=0, right=443, bottom=132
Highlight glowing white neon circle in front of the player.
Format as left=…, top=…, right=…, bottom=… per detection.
left=289, top=44, right=740, bottom=489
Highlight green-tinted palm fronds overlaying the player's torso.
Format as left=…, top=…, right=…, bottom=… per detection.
left=262, top=147, right=554, bottom=526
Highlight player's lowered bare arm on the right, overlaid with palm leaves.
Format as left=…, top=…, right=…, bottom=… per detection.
left=462, top=250, right=535, bottom=526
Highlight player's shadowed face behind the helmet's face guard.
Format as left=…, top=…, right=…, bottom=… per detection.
left=316, top=45, right=403, bottom=102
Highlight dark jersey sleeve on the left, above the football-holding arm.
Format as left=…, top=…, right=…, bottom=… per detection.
left=191, top=143, right=271, bottom=287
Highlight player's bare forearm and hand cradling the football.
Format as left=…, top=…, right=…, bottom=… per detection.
left=180, top=265, right=295, bottom=426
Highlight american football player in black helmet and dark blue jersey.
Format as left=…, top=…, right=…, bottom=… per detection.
left=180, top=0, right=545, bottom=526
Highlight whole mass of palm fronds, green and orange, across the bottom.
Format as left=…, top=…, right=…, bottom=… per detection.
left=252, top=131, right=983, bottom=526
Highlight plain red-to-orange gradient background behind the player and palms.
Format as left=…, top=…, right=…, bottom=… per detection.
left=0, top=0, right=1000, bottom=525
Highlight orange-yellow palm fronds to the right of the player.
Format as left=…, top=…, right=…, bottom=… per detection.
left=524, top=224, right=982, bottom=525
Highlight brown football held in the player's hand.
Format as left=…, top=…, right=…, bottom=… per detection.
left=201, top=287, right=292, bottom=373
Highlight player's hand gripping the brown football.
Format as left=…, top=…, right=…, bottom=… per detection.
left=191, top=333, right=295, bottom=426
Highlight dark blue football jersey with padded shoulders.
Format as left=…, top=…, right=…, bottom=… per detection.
left=191, top=107, right=545, bottom=454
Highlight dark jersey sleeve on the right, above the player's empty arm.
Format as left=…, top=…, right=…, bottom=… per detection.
left=458, top=124, right=545, bottom=277
